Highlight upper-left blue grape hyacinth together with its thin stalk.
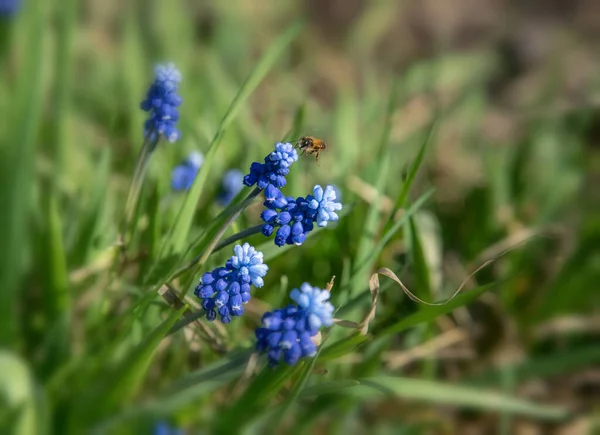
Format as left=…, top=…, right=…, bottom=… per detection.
left=125, top=63, right=182, bottom=230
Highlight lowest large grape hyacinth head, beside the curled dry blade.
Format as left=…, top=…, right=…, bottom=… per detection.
left=255, top=282, right=334, bottom=366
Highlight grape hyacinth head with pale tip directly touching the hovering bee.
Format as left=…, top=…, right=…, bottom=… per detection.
left=244, top=142, right=298, bottom=189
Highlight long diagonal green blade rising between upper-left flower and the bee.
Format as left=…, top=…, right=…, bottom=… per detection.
left=167, top=23, right=302, bottom=253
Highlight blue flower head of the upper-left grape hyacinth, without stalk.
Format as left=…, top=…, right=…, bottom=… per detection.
left=141, top=63, right=182, bottom=142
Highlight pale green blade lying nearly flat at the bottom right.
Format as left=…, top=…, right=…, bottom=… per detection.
left=346, top=376, right=569, bottom=420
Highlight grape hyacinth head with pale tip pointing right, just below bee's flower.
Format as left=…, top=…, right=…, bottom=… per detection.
left=260, top=185, right=342, bottom=246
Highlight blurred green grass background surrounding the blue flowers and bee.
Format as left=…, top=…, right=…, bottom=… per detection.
left=0, top=0, right=600, bottom=434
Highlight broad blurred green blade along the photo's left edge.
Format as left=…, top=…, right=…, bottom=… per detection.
left=0, top=0, right=48, bottom=347
